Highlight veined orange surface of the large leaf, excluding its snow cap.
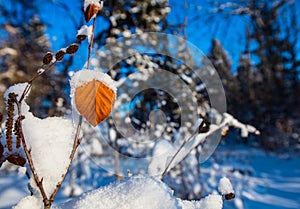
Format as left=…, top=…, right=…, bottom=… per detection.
left=75, top=79, right=115, bottom=126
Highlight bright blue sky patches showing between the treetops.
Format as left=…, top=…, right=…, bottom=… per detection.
left=40, top=0, right=300, bottom=70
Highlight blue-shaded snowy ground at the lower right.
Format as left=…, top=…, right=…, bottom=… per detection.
left=202, top=145, right=300, bottom=209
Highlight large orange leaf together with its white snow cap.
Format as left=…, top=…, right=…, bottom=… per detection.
left=71, top=70, right=117, bottom=126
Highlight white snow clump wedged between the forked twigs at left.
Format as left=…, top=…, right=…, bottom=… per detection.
left=23, top=112, right=74, bottom=196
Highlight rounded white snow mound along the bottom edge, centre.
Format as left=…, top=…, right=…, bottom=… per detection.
left=54, top=175, right=223, bottom=209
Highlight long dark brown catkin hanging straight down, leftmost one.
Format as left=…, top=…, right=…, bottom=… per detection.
left=5, top=93, right=17, bottom=152
